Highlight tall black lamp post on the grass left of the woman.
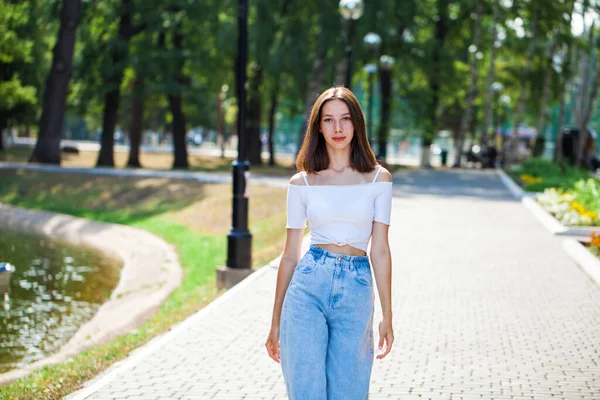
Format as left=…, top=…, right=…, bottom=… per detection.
left=217, top=0, right=254, bottom=288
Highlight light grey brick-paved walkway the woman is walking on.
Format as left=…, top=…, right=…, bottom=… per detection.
left=63, top=171, right=600, bottom=400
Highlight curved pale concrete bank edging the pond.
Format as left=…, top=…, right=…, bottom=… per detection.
left=0, top=203, right=183, bottom=385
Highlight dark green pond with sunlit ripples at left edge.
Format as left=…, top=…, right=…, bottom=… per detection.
left=0, top=229, right=121, bottom=373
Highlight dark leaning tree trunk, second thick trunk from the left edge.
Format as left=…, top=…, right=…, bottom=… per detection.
left=96, top=0, right=137, bottom=167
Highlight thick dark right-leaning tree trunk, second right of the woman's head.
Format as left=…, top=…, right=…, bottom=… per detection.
left=421, top=0, right=449, bottom=168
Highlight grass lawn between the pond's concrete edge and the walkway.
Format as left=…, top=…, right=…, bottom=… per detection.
left=0, top=171, right=286, bottom=400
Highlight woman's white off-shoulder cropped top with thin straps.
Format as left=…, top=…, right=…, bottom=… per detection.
left=287, top=166, right=392, bottom=251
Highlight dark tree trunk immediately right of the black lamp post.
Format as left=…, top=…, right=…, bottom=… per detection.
left=245, top=64, right=263, bottom=165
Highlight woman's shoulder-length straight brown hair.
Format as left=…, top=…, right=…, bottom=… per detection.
left=296, top=86, right=378, bottom=173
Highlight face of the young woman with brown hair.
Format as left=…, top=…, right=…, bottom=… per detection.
left=319, top=100, right=354, bottom=149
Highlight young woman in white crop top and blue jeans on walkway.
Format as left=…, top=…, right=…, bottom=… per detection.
left=266, top=87, right=394, bottom=400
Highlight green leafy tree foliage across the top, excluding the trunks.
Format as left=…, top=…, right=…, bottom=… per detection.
left=0, top=0, right=589, bottom=155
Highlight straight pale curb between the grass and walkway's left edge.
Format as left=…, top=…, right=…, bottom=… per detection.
left=65, top=234, right=310, bottom=400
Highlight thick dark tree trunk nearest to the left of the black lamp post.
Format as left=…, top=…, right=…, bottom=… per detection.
left=168, top=24, right=189, bottom=169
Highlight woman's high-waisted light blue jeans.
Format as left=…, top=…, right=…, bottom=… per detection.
left=279, top=245, right=374, bottom=400
